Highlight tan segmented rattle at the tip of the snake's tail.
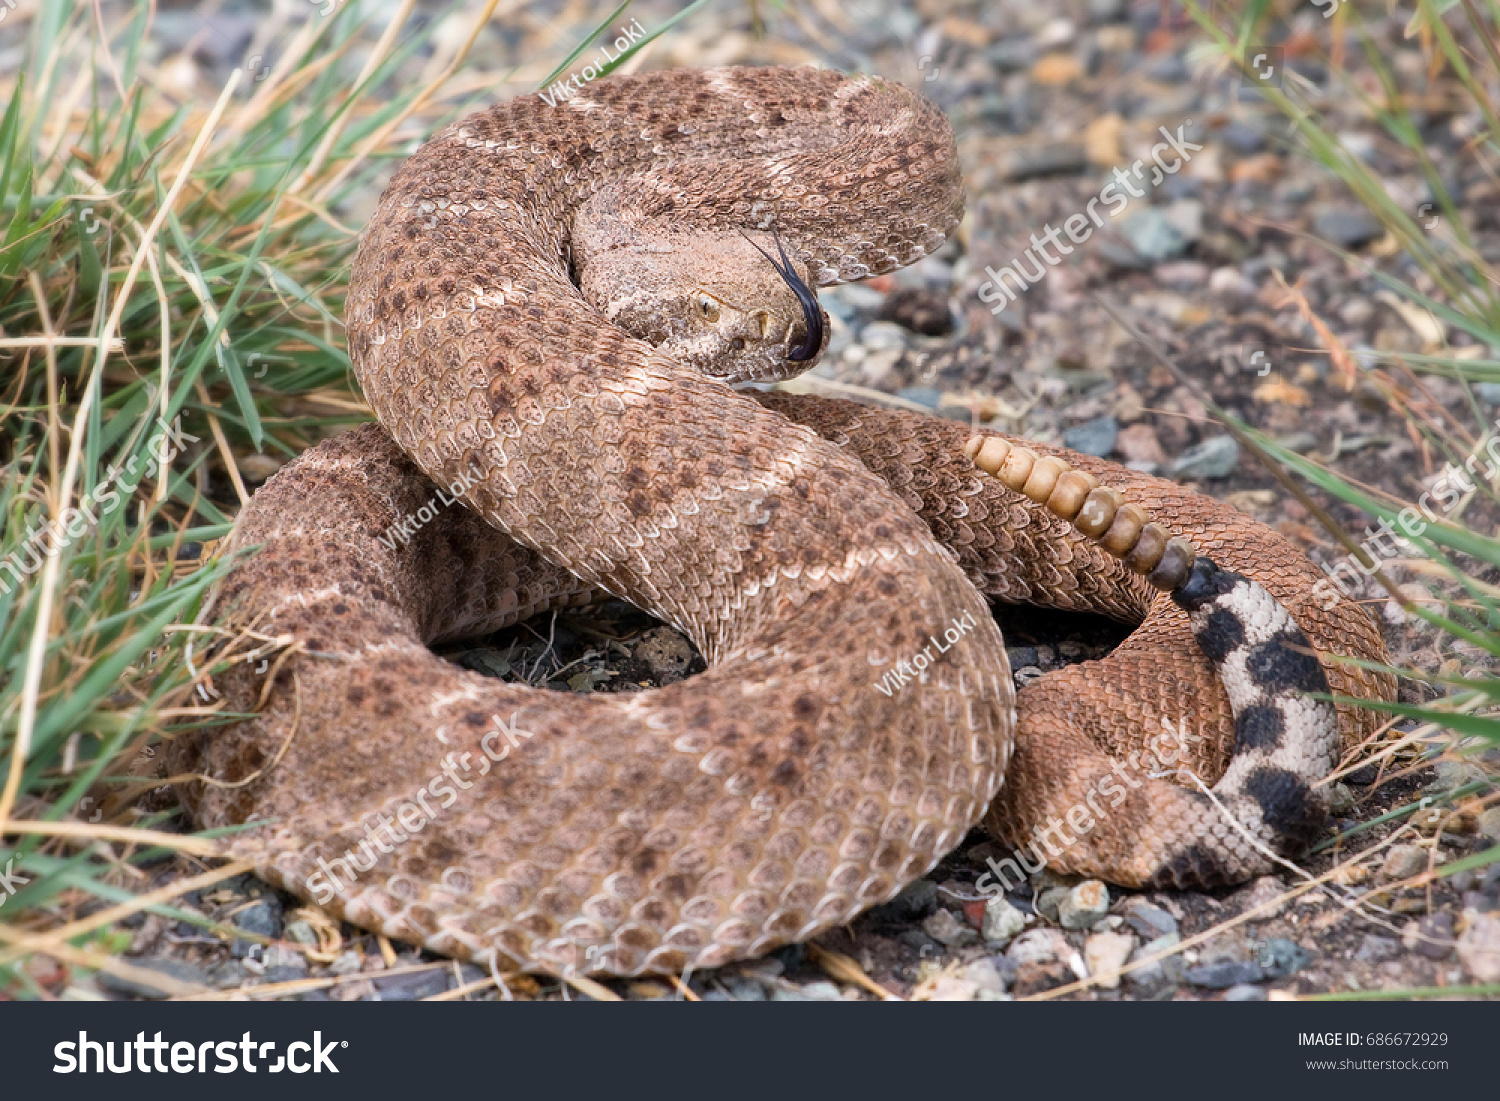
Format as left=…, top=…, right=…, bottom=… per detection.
left=963, top=437, right=1197, bottom=593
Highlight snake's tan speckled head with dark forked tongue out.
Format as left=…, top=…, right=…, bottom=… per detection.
left=581, top=222, right=828, bottom=383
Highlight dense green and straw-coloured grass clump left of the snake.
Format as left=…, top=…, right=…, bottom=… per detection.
left=0, top=0, right=651, bottom=996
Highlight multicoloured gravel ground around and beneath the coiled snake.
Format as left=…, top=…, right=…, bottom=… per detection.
left=29, top=0, right=1500, bottom=1001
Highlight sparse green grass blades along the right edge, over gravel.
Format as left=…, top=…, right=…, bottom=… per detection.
left=1185, top=0, right=1500, bottom=873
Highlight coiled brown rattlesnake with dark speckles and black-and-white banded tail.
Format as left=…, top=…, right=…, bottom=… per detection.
left=170, top=69, right=1391, bottom=974
